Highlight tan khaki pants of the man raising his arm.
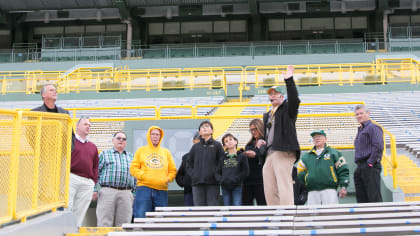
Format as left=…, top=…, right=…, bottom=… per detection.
left=263, top=151, right=296, bottom=205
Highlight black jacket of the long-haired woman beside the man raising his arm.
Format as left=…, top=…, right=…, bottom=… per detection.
left=244, top=139, right=265, bottom=185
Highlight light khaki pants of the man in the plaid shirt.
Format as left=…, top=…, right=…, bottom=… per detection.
left=96, top=187, right=134, bottom=227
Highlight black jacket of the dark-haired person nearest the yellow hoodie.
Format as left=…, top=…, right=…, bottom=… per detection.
left=187, top=138, right=225, bottom=186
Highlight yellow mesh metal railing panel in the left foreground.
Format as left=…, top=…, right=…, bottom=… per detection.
left=0, top=110, right=71, bottom=224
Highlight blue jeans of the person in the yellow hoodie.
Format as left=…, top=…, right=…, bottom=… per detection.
left=134, top=186, right=168, bottom=218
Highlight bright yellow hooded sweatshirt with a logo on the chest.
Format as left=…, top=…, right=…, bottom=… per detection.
left=130, top=126, right=176, bottom=191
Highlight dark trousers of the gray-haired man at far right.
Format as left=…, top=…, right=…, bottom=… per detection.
left=354, top=161, right=382, bottom=203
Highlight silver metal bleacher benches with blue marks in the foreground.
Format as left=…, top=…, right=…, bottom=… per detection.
left=109, top=202, right=420, bottom=236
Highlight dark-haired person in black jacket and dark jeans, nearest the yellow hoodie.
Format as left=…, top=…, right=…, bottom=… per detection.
left=187, top=121, right=225, bottom=206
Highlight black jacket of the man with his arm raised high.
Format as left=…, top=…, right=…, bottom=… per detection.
left=263, top=78, right=300, bottom=160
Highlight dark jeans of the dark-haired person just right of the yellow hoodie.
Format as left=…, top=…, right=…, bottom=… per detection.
left=193, top=184, right=220, bottom=206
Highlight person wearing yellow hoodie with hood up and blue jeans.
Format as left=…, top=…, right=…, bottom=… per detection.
left=130, top=126, right=176, bottom=218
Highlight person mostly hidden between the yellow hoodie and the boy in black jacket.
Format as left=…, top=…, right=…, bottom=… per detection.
left=175, top=132, right=200, bottom=206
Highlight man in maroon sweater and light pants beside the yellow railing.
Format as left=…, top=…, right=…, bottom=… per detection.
left=69, top=118, right=99, bottom=226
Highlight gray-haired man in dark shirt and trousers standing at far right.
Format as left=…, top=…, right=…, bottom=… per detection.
left=354, top=105, right=384, bottom=203
